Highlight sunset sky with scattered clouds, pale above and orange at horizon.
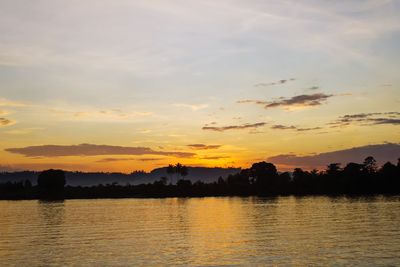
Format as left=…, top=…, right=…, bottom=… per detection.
left=0, top=0, right=400, bottom=172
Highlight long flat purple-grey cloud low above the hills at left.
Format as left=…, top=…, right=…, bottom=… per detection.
left=5, top=144, right=196, bottom=158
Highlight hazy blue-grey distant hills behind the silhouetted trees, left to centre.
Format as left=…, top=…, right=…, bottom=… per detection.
left=0, top=167, right=240, bottom=186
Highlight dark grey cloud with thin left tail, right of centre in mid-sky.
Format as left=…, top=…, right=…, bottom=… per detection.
left=237, top=93, right=334, bottom=109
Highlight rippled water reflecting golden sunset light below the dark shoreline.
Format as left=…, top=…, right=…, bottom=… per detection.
left=0, top=197, right=400, bottom=266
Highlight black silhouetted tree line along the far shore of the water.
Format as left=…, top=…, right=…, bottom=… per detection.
left=0, top=157, right=400, bottom=199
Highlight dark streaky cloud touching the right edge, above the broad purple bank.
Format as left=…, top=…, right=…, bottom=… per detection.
left=328, top=111, right=400, bottom=128
